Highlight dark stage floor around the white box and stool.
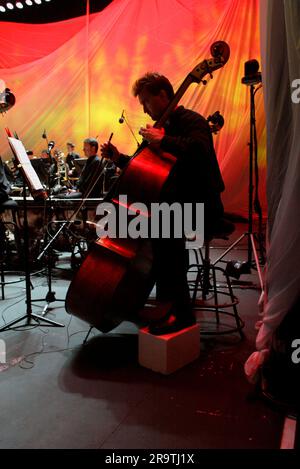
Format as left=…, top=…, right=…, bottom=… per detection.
left=0, top=225, right=283, bottom=449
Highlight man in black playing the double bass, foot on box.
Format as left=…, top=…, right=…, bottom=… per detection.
left=101, top=73, right=224, bottom=335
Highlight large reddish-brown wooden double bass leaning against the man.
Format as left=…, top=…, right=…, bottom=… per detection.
left=66, top=41, right=230, bottom=332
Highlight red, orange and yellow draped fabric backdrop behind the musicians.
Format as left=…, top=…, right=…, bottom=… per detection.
left=0, top=0, right=266, bottom=214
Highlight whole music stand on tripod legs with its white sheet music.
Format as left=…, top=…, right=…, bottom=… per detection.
left=0, top=129, right=64, bottom=332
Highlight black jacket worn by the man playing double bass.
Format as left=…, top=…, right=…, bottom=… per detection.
left=118, top=106, right=225, bottom=214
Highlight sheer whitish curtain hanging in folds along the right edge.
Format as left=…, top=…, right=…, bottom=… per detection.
left=246, top=0, right=300, bottom=372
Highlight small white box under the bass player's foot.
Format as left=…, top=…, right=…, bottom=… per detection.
left=139, top=324, right=200, bottom=375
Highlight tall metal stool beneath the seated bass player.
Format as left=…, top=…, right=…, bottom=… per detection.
left=188, top=218, right=245, bottom=338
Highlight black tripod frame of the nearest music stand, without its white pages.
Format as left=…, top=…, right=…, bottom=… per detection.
left=0, top=133, right=64, bottom=332
